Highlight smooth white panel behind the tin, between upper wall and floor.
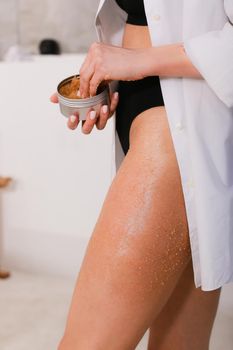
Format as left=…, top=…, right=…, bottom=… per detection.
left=0, top=55, right=113, bottom=275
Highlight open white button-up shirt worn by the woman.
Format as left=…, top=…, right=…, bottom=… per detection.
left=95, top=0, right=233, bottom=291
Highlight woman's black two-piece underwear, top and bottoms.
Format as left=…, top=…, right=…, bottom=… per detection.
left=116, top=0, right=164, bottom=154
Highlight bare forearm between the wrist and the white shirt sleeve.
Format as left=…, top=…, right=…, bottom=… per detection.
left=141, top=43, right=203, bottom=78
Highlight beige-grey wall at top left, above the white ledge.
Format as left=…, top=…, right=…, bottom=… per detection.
left=0, top=0, right=99, bottom=57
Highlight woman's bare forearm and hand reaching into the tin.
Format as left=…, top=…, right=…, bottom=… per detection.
left=79, top=42, right=202, bottom=98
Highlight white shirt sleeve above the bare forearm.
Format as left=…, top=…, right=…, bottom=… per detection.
left=183, top=0, right=233, bottom=107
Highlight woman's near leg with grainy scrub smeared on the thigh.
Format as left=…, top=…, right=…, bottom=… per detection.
left=59, top=107, right=191, bottom=350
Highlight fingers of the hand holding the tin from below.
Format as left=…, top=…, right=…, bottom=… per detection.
left=50, top=92, right=119, bottom=134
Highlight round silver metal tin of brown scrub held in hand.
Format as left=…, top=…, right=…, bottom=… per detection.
left=57, top=74, right=110, bottom=120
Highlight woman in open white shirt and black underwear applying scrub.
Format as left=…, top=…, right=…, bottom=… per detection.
left=52, top=0, right=233, bottom=350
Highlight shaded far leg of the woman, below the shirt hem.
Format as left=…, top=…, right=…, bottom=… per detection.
left=148, top=260, right=221, bottom=350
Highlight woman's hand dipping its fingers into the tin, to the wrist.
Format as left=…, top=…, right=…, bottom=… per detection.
left=79, top=42, right=146, bottom=98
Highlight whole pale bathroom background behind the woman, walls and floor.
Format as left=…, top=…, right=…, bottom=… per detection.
left=0, top=0, right=233, bottom=350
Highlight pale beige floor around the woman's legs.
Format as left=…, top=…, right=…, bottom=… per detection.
left=0, top=271, right=233, bottom=350
